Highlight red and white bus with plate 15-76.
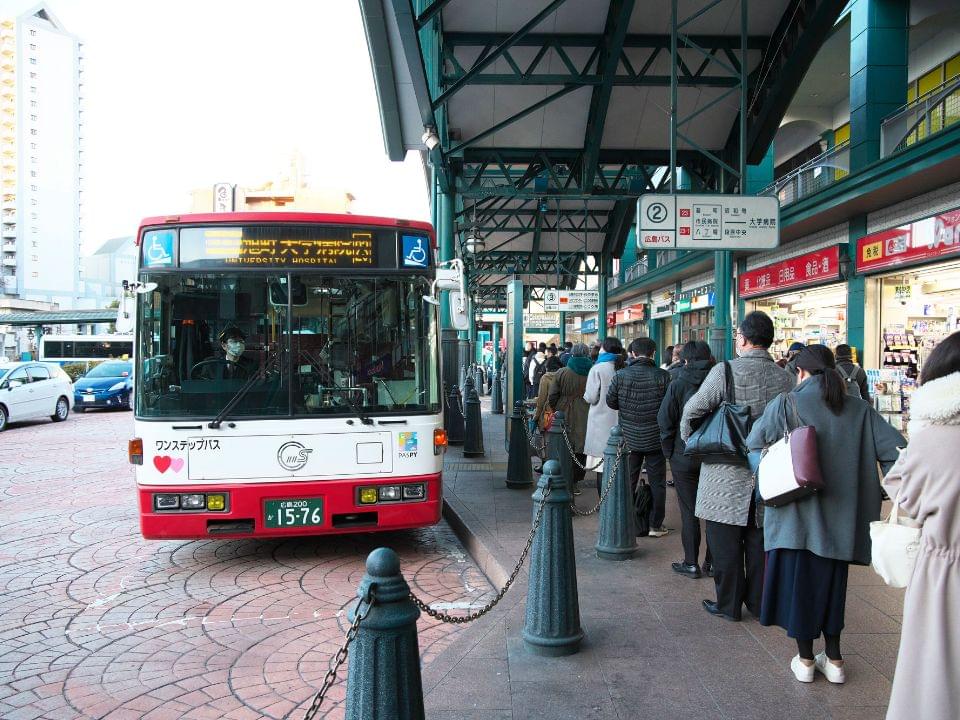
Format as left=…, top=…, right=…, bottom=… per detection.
left=130, top=213, right=454, bottom=538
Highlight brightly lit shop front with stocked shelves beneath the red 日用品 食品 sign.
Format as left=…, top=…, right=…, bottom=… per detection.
left=746, top=283, right=847, bottom=359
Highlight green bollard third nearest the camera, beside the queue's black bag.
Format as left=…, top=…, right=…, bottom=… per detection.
left=596, top=425, right=637, bottom=560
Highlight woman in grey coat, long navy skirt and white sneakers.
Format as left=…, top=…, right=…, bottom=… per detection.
left=747, top=345, right=907, bottom=683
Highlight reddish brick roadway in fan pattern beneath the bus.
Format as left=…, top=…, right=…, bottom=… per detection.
left=0, top=412, right=491, bottom=720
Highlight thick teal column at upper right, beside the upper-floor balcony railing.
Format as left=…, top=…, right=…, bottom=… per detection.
left=850, top=0, right=910, bottom=172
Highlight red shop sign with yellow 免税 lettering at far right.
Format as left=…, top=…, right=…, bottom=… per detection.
left=857, top=210, right=960, bottom=272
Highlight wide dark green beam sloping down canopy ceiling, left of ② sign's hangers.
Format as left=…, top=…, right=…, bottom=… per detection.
left=581, top=0, right=634, bottom=190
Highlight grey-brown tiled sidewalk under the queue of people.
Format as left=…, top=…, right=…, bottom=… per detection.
left=424, top=399, right=903, bottom=720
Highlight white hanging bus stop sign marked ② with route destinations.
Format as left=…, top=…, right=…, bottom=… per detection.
left=637, top=194, right=780, bottom=250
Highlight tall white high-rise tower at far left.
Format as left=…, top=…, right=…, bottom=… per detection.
left=0, top=3, right=83, bottom=309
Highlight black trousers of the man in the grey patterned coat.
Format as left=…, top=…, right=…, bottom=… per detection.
left=707, top=500, right=763, bottom=620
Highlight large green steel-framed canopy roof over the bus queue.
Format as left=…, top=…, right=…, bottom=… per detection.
left=360, top=0, right=846, bottom=306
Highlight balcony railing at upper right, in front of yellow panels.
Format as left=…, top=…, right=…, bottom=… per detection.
left=880, top=77, right=960, bottom=157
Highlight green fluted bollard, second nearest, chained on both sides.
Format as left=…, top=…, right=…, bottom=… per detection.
left=523, top=460, right=583, bottom=657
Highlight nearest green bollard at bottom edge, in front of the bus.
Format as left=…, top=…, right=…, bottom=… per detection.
left=344, top=548, right=424, bottom=720
